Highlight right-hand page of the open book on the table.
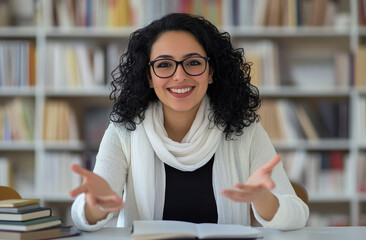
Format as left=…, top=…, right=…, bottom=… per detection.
left=196, top=223, right=262, bottom=238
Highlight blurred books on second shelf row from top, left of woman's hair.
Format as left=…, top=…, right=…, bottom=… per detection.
left=0, top=41, right=124, bottom=90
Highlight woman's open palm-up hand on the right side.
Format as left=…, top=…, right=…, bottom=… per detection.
left=221, top=155, right=281, bottom=206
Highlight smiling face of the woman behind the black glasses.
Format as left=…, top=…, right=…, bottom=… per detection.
left=149, top=31, right=212, bottom=119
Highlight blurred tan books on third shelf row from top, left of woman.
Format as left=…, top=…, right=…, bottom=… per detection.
left=0, top=98, right=110, bottom=142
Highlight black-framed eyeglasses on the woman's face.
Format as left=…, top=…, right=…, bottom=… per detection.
left=149, top=56, right=210, bottom=78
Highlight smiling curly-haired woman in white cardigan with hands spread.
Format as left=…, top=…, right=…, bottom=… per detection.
left=70, top=14, right=309, bottom=231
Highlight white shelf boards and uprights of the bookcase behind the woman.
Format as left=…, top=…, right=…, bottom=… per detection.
left=0, top=0, right=366, bottom=225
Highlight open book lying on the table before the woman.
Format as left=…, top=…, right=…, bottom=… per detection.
left=131, top=220, right=262, bottom=240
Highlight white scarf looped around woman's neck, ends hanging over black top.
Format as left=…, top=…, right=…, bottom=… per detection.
left=131, top=97, right=246, bottom=224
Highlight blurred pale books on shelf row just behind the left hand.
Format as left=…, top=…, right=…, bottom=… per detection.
left=0, top=150, right=96, bottom=197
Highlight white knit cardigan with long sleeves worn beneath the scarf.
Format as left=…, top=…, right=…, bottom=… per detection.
left=71, top=123, right=309, bottom=231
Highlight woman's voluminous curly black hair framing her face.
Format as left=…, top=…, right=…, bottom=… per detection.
left=110, top=13, right=261, bottom=139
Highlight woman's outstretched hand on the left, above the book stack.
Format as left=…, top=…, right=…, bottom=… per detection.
left=70, top=164, right=124, bottom=212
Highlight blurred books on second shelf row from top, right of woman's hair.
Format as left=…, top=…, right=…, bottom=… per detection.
left=243, top=40, right=366, bottom=89
